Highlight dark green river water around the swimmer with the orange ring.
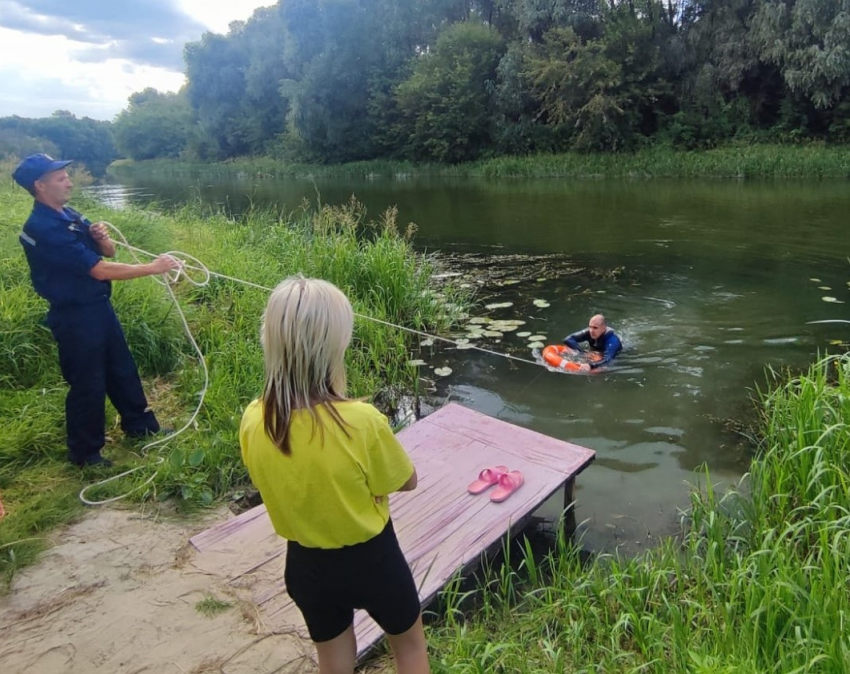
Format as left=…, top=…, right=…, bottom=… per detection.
left=89, top=176, right=850, bottom=552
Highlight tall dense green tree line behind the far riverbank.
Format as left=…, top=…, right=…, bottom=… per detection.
left=0, top=0, right=850, bottom=169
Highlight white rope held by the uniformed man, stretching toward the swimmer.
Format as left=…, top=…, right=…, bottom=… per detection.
left=79, top=222, right=549, bottom=506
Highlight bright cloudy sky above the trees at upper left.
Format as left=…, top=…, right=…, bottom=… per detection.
left=0, top=0, right=276, bottom=120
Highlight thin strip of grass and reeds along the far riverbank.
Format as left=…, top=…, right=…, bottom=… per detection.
left=110, top=144, right=850, bottom=179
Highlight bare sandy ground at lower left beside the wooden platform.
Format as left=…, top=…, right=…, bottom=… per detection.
left=0, top=509, right=316, bottom=674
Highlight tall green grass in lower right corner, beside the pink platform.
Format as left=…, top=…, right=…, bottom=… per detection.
left=430, top=356, right=850, bottom=674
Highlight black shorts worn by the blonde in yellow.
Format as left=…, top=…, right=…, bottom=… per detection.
left=284, top=520, right=420, bottom=642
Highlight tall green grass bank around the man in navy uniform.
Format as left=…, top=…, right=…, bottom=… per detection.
left=0, top=167, right=465, bottom=580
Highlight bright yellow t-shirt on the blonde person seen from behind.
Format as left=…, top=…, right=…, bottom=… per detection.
left=239, top=400, right=413, bottom=549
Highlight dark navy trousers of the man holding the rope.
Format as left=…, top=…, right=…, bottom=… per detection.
left=47, top=298, right=159, bottom=463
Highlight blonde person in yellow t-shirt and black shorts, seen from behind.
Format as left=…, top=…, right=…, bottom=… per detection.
left=239, top=277, right=430, bottom=674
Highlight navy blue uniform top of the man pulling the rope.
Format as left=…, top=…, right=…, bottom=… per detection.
left=19, top=201, right=112, bottom=309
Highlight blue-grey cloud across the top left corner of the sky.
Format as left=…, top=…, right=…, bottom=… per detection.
left=0, top=0, right=205, bottom=70
